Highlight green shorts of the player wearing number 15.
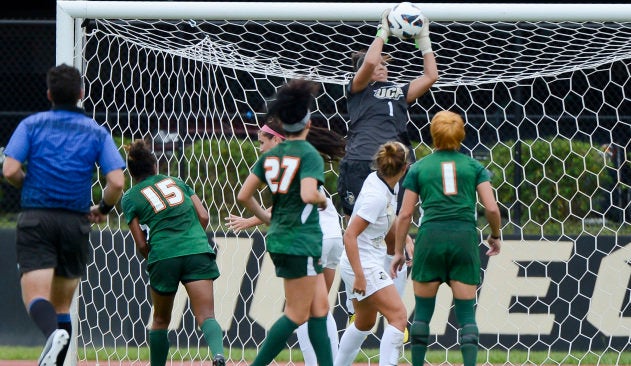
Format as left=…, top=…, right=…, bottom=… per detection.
left=147, top=253, right=219, bottom=295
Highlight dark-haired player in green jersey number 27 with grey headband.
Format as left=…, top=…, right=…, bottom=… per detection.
left=237, top=79, right=333, bottom=366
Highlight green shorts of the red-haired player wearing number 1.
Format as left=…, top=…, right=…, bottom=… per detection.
left=411, top=222, right=480, bottom=285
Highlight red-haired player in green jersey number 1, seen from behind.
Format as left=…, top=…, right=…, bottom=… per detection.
left=390, top=111, right=501, bottom=366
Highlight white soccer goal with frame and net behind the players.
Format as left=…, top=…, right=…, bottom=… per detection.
left=57, top=1, right=631, bottom=365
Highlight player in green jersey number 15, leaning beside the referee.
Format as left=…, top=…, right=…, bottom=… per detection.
left=122, top=140, right=225, bottom=366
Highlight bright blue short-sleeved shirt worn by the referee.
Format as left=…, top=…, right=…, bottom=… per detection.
left=4, top=106, right=125, bottom=212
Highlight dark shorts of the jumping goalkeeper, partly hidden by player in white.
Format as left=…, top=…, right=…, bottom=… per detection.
left=337, top=157, right=413, bottom=216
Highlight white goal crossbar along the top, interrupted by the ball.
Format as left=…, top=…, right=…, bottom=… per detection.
left=57, top=0, right=631, bottom=22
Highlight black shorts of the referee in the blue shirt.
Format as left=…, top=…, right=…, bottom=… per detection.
left=16, top=209, right=90, bottom=278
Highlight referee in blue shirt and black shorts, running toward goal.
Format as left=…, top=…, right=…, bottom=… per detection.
left=2, top=64, right=125, bottom=366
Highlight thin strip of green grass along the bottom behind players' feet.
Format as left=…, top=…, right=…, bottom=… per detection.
left=0, top=346, right=631, bottom=365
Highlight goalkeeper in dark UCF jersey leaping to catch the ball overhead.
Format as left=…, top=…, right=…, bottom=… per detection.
left=337, top=4, right=438, bottom=340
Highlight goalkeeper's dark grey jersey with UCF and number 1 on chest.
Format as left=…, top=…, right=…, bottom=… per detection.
left=345, top=81, right=411, bottom=160
